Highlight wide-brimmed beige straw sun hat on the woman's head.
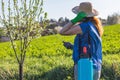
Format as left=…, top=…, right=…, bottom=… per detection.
left=72, top=2, right=99, bottom=17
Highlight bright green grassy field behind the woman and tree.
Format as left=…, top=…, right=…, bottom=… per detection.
left=0, top=24, right=120, bottom=80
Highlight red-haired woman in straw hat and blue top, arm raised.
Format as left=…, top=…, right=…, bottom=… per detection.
left=60, top=2, right=103, bottom=80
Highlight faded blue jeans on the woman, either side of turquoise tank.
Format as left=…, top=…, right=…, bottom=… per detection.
left=74, top=64, right=101, bottom=80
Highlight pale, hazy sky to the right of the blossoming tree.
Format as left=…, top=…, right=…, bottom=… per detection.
left=44, top=0, right=120, bottom=19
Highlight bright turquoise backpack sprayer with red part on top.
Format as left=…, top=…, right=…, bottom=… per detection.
left=78, top=46, right=93, bottom=80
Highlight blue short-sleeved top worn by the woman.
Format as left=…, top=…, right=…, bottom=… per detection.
left=73, top=21, right=102, bottom=70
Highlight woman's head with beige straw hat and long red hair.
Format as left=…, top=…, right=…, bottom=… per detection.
left=72, top=2, right=103, bottom=36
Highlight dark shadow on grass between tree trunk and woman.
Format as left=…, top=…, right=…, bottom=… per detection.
left=41, top=66, right=73, bottom=80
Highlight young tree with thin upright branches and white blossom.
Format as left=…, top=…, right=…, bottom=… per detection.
left=0, top=0, right=47, bottom=80
